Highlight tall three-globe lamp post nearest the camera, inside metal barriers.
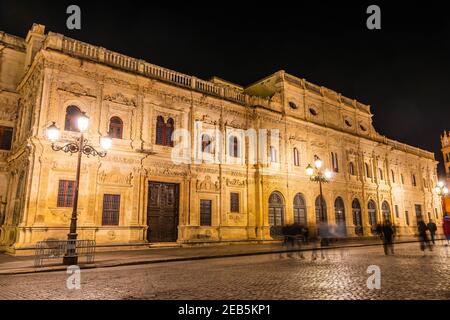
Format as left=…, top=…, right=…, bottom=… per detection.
left=47, top=112, right=112, bottom=265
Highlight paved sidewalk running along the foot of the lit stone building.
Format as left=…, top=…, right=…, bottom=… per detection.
left=0, top=237, right=417, bottom=275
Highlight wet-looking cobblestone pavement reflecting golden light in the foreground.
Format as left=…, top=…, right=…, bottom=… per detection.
left=0, top=243, right=450, bottom=300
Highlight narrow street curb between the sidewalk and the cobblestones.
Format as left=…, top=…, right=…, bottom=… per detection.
left=0, top=239, right=432, bottom=276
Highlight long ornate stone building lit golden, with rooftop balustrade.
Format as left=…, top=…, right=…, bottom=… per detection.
left=0, top=25, right=442, bottom=253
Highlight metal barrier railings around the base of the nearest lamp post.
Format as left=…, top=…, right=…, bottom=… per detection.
left=34, top=240, right=95, bottom=267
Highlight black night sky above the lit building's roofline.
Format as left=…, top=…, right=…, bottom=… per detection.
left=0, top=0, right=450, bottom=175
